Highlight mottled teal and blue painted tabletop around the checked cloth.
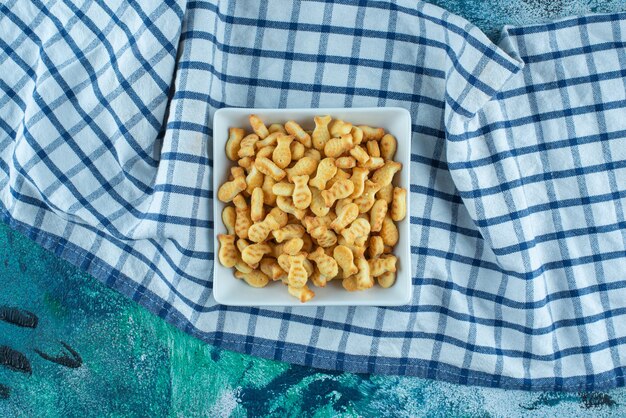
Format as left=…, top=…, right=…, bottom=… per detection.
left=0, top=0, right=626, bottom=417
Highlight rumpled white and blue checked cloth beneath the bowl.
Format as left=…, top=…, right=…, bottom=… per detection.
left=0, top=0, right=626, bottom=390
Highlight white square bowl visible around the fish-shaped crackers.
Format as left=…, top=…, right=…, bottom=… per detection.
left=213, top=107, right=413, bottom=306
